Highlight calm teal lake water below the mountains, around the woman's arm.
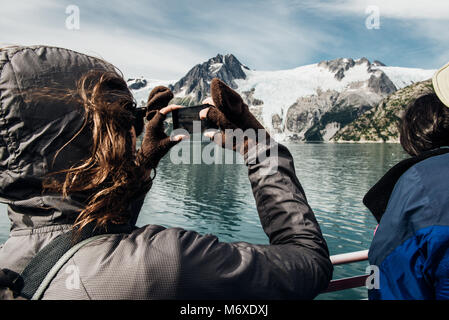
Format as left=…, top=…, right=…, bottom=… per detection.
left=0, top=144, right=406, bottom=299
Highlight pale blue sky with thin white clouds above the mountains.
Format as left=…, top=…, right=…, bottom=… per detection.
left=0, top=0, right=449, bottom=80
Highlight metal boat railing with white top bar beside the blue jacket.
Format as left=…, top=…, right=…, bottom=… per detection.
left=322, top=250, right=368, bottom=293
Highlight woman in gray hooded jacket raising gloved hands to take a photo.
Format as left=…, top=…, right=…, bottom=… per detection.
left=0, top=46, right=332, bottom=300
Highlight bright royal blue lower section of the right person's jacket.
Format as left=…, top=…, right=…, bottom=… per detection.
left=369, top=226, right=449, bottom=300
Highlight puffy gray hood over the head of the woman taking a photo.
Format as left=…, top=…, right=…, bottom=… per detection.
left=0, top=46, right=140, bottom=231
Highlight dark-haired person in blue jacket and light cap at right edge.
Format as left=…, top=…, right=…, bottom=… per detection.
left=364, top=67, right=449, bottom=300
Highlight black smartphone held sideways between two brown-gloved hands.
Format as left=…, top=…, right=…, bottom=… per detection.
left=172, top=104, right=218, bottom=134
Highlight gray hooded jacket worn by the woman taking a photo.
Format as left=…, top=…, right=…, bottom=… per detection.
left=0, top=46, right=332, bottom=299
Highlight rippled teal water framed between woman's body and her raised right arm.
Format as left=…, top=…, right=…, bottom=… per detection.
left=142, top=142, right=268, bottom=243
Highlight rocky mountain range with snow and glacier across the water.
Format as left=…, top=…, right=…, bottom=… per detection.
left=128, top=54, right=435, bottom=141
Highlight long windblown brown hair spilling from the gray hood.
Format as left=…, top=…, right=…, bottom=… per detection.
left=39, top=71, right=152, bottom=232
